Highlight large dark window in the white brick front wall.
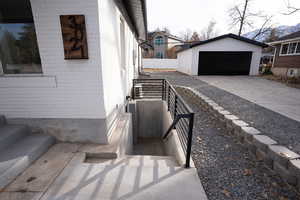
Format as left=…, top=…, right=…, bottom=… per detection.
left=0, top=0, right=42, bottom=74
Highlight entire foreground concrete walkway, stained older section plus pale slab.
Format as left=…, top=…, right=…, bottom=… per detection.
left=0, top=143, right=207, bottom=200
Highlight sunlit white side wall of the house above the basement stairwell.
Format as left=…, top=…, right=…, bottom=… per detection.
left=98, top=0, right=138, bottom=115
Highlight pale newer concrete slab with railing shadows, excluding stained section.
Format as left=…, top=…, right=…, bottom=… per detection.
left=40, top=154, right=207, bottom=200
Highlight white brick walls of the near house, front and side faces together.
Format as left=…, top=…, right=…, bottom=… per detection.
left=0, top=0, right=138, bottom=122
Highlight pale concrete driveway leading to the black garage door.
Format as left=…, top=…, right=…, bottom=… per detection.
left=196, top=76, right=300, bottom=122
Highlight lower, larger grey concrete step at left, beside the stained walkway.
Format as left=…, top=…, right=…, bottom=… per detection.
left=0, top=134, right=55, bottom=191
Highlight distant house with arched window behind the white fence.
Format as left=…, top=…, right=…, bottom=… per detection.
left=143, top=31, right=184, bottom=59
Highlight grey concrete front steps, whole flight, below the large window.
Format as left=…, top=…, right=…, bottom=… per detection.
left=0, top=116, right=55, bottom=191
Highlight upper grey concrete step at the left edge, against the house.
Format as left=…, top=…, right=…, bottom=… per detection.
left=0, top=125, right=30, bottom=151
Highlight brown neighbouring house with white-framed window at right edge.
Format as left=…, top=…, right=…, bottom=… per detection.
left=269, top=31, right=300, bottom=77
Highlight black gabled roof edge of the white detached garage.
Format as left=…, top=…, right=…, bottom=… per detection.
left=178, top=33, right=268, bottom=52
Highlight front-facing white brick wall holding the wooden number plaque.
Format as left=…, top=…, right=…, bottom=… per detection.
left=0, top=0, right=106, bottom=118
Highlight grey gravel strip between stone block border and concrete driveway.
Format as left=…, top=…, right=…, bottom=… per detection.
left=146, top=72, right=300, bottom=154
